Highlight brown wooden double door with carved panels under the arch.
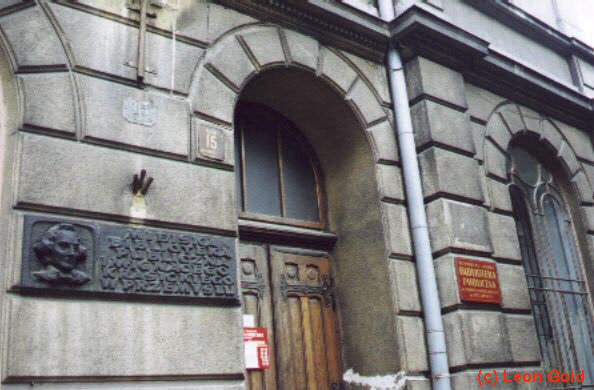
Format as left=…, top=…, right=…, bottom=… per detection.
left=240, top=244, right=341, bottom=390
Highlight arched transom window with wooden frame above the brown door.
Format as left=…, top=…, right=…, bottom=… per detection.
left=236, top=103, right=323, bottom=228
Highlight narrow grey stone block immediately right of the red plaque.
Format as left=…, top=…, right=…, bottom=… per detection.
left=497, top=264, right=531, bottom=310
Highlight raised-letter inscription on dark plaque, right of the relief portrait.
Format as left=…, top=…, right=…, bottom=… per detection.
left=99, top=229, right=236, bottom=297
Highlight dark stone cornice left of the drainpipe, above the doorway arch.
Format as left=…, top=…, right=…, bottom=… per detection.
left=209, top=0, right=389, bottom=62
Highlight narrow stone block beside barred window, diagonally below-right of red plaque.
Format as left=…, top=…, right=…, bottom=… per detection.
left=505, top=314, right=540, bottom=363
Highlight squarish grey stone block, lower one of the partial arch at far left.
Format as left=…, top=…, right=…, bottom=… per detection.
left=19, top=73, right=76, bottom=135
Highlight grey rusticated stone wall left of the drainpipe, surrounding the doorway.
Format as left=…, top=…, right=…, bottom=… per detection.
left=0, top=0, right=414, bottom=390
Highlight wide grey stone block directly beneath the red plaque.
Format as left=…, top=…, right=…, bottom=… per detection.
left=443, top=310, right=512, bottom=367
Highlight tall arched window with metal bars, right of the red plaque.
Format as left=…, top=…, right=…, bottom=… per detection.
left=510, top=145, right=594, bottom=387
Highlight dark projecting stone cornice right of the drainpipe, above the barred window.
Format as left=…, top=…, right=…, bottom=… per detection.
left=389, top=6, right=594, bottom=129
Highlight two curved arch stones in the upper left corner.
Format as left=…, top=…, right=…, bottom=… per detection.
left=0, top=4, right=81, bottom=137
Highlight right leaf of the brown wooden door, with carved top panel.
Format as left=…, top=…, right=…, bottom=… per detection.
left=270, top=249, right=340, bottom=390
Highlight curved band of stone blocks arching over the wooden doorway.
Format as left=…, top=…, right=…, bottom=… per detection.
left=190, top=25, right=387, bottom=133
